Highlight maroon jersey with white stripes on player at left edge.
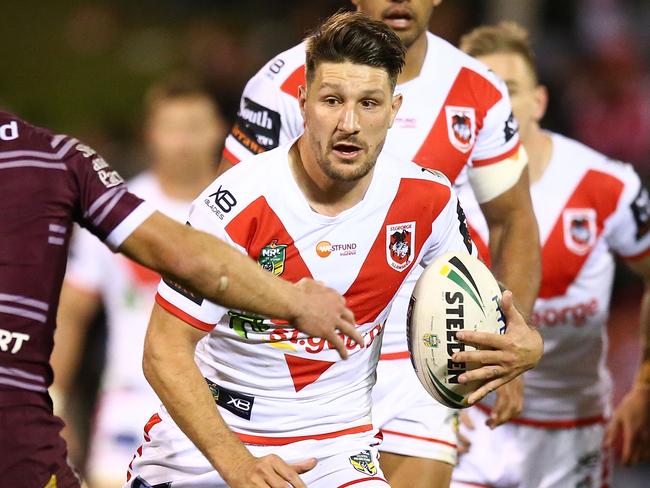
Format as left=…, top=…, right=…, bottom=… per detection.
left=0, top=112, right=151, bottom=406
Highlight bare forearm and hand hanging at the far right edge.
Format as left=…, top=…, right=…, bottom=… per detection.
left=607, top=256, right=650, bottom=464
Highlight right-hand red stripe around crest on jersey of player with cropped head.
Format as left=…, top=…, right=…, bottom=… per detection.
left=413, top=68, right=501, bottom=182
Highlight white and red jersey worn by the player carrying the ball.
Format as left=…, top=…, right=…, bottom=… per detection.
left=156, top=143, right=475, bottom=445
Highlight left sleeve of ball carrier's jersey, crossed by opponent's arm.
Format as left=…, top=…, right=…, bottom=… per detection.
left=156, top=186, right=245, bottom=332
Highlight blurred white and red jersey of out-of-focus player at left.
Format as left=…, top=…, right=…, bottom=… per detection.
left=65, top=172, right=191, bottom=398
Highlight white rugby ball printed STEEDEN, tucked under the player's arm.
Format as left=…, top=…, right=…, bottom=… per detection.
left=406, top=252, right=505, bottom=408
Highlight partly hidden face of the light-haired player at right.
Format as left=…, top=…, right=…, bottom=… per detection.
left=477, top=53, right=546, bottom=143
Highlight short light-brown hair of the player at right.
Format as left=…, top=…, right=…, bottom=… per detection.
left=460, top=21, right=537, bottom=82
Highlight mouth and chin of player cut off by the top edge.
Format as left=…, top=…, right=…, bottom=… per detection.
left=352, top=0, right=442, bottom=48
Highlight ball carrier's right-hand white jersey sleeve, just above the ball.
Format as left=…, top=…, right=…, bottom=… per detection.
left=420, top=178, right=478, bottom=267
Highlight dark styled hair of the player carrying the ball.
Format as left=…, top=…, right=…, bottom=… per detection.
left=306, top=12, right=406, bottom=88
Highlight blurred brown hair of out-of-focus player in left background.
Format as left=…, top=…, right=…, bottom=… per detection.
left=144, top=73, right=221, bottom=117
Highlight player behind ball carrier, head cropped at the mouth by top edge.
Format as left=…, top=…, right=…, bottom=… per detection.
left=221, top=0, right=540, bottom=488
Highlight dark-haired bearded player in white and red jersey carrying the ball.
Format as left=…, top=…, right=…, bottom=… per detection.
left=130, top=13, right=541, bottom=488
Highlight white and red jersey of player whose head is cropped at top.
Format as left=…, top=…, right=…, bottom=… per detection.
left=224, top=33, right=525, bottom=358
